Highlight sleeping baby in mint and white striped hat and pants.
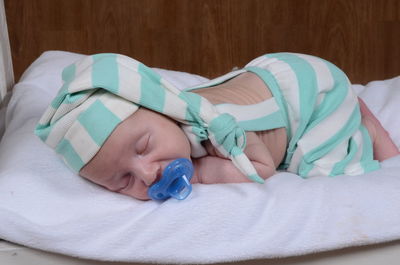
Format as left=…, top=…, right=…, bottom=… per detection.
left=35, top=53, right=399, bottom=200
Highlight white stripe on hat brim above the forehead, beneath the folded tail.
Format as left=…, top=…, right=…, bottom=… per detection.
left=99, top=93, right=139, bottom=121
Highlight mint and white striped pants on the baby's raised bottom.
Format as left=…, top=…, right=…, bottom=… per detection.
left=245, top=53, right=380, bottom=177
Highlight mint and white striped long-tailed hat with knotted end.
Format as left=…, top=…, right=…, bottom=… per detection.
left=35, top=54, right=263, bottom=183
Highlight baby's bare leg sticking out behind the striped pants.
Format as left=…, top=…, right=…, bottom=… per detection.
left=358, top=98, right=400, bottom=161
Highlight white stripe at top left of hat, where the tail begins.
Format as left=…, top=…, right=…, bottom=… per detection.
left=68, top=56, right=93, bottom=93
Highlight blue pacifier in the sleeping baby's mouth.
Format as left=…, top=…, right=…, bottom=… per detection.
left=147, top=158, right=193, bottom=200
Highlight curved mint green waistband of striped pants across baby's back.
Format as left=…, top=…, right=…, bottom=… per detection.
left=246, top=66, right=292, bottom=140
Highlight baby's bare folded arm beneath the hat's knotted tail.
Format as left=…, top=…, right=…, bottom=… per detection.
left=192, top=132, right=276, bottom=184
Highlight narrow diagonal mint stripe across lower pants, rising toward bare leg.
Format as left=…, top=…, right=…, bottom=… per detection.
left=299, top=106, right=361, bottom=175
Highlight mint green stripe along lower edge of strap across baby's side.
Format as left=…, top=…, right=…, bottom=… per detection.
left=238, top=110, right=286, bottom=131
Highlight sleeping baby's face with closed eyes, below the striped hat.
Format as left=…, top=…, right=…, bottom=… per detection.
left=79, top=108, right=190, bottom=200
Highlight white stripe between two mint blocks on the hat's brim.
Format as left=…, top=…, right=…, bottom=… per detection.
left=64, top=120, right=99, bottom=164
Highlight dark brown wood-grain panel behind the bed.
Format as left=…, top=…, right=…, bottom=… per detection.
left=5, top=0, right=400, bottom=83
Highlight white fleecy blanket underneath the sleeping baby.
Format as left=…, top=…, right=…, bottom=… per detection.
left=0, top=52, right=400, bottom=263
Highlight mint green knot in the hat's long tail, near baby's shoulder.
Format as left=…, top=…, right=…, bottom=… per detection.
left=209, top=113, right=246, bottom=155
